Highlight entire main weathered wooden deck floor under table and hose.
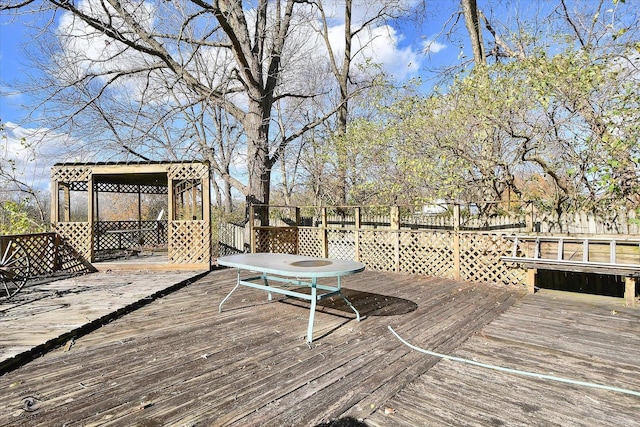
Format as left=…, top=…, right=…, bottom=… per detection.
left=0, top=270, right=640, bottom=426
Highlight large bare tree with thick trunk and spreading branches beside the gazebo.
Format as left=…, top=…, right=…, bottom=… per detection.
left=2, top=0, right=344, bottom=224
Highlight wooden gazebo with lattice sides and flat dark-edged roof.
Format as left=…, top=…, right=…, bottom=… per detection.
left=51, top=161, right=211, bottom=270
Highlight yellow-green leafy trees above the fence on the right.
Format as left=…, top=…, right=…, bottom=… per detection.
left=332, top=0, right=640, bottom=217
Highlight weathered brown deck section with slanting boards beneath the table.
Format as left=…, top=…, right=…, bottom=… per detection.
left=0, top=270, right=520, bottom=426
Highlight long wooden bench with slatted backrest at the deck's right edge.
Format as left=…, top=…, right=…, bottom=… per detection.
left=500, top=236, right=640, bottom=307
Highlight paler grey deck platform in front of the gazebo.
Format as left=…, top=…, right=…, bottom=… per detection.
left=0, top=271, right=202, bottom=372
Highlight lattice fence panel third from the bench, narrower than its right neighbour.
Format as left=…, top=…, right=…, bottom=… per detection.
left=359, top=230, right=398, bottom=271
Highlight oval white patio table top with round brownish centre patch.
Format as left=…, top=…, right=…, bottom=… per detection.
left=218, top=253, right=364, bottom=277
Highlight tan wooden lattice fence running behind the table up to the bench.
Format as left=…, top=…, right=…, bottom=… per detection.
left=240, top=208, right=527, bottom=285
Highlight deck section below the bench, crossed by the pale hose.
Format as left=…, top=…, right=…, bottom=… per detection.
left=367, top=291, right=640, bottom=426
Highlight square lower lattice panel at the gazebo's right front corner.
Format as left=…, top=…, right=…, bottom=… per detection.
left=168, top=221, right=211, bottom=264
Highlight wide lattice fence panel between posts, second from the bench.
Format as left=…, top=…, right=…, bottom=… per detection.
left=399, top=231, right=455, bottom=279
